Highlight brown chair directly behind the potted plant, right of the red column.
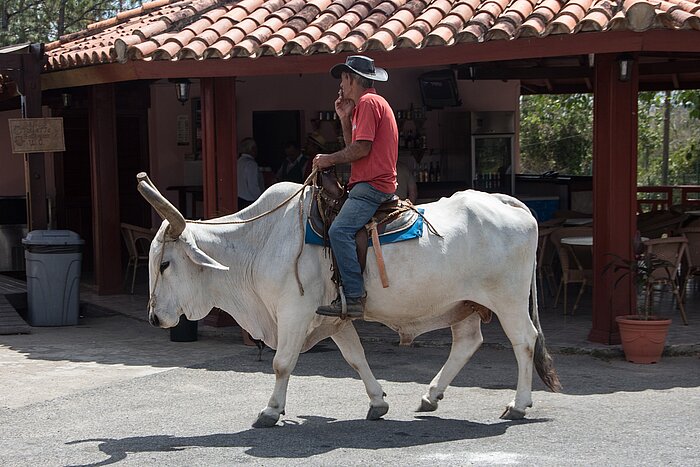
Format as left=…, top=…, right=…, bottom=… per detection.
left=644, top=237, right=688, bottom=325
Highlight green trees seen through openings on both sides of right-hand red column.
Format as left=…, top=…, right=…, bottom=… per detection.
left=520, top=90, right=700, bottom=185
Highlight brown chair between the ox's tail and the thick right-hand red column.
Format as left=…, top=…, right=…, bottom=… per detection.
left=549, top=227, right=593, bottom=315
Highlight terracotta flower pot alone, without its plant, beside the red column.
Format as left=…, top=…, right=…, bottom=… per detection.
left=615, top=315, right=671, bottom=363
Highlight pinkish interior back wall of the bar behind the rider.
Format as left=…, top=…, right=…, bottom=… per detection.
left=149, top=68, right=519, bottom=211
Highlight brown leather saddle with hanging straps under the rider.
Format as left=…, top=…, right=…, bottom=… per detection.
left=309, top=171, right=419, bottom=287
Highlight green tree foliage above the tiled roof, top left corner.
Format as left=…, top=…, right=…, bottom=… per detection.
left=0, top=0, right=141, bottom=46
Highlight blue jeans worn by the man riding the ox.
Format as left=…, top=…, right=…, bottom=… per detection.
left=328, top=183, right=394, bottom=298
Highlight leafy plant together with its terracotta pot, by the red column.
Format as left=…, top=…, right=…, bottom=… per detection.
left=603, top=239, right=675, bottom=363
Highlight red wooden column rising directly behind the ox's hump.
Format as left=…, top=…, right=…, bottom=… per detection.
left=201, top=78, right=238, bottom=218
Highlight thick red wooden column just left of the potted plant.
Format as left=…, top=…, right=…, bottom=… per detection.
left=588, top=54, right=639, bottom=344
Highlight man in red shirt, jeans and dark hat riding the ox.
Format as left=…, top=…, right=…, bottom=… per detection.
left=313, top=55, right=399, bottom=318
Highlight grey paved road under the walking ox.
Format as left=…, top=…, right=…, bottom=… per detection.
left=0, top=315, right=700, bottom=467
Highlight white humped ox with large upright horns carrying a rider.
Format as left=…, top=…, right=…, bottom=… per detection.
left=139, top=174, right=560, bottom=427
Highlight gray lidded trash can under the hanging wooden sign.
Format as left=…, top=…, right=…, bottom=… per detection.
left=22, top=230, right=85, bottom=326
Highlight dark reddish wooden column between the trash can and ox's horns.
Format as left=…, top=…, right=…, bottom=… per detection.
left=88, top=84, right=122, bottom=295
